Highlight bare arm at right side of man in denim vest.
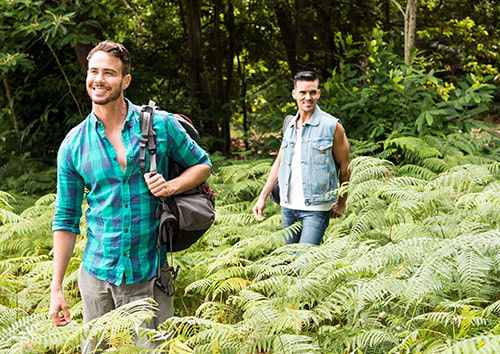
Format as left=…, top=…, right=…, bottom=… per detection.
left=331, top=123, right=351, bottom=218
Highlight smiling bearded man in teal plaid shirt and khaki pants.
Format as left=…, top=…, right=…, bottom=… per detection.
left=49, top=41, right=211, bottom=353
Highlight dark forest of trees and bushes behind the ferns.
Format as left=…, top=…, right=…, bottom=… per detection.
left=0, top=0, right=500, bottom=196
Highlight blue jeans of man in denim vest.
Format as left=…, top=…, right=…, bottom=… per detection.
left=281, top=207, right=330, bottom=245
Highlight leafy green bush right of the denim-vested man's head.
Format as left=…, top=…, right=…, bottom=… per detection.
left=320, top=33, right=494, bottom=141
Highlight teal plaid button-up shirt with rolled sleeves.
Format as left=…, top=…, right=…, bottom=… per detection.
left=52, top=100, right=211, bottom=285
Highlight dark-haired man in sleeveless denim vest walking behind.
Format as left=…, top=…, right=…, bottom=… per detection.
left=253, top=71, right=350, bottom=245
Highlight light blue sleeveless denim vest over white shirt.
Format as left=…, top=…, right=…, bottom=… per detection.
left=278, top=107, right=338, bottom=205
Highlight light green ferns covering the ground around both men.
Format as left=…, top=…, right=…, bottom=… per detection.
left=0, top=133, right=500, bottom=353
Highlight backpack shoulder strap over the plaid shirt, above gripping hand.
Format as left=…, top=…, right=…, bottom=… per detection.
left=139, top=101, right=156, bottom=173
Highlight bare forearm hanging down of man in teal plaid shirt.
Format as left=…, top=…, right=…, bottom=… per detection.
left=49, top=231, right=76, bottom=326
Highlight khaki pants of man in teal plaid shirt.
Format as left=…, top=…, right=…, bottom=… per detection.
left=78, top=267, right=173, bottom=353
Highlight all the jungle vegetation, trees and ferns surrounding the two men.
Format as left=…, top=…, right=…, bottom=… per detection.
left=0, top=0, right=500, bottom=354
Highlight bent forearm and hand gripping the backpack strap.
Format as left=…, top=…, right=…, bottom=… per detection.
left=144, top=164, right=211, bottom=197
